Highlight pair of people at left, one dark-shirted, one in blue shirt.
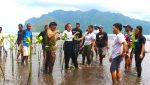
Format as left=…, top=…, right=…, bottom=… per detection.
left=16, top=23, right=32, bottom=64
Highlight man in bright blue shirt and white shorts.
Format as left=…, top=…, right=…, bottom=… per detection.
left=22, top=23, right=32, bottom=64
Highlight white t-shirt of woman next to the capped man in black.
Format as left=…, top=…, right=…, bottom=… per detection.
left=84, top=33, right=96, bottom=46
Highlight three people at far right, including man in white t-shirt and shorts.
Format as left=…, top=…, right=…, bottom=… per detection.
left=109, top=23, right=146, bottom=82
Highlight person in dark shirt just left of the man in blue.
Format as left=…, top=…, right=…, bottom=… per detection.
left=16, top=24, right=23, bottom=61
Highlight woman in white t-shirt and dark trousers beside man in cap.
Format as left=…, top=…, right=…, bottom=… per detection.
left=82, top=25, right=96, bottom=66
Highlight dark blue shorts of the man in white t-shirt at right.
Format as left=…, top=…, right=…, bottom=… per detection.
left=110, top=56, right=122, bottom=71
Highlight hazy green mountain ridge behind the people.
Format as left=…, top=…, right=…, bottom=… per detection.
left=25, top=10, right=150, bottom=34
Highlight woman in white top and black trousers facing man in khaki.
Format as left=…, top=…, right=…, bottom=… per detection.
left=63, top=23, right=78, bottom=69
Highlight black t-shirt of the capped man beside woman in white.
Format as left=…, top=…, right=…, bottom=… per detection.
left=96, top=32, right=108, bottom=48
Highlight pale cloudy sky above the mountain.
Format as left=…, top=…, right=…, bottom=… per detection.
left=0, top=0, right=150, bottom=33
